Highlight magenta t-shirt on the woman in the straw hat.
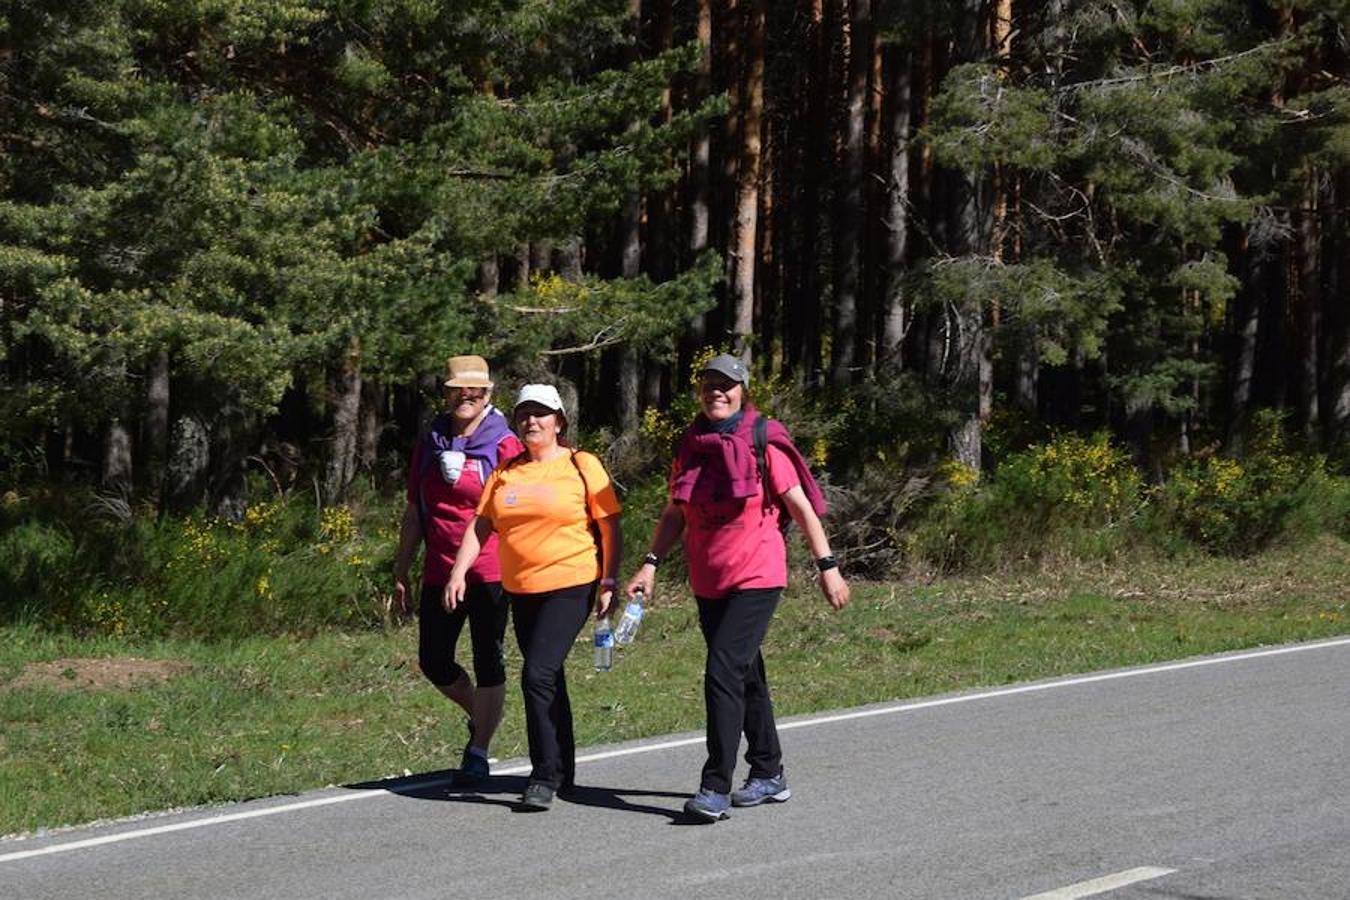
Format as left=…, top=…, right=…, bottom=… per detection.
left=408, top=434, right=525, bottom=584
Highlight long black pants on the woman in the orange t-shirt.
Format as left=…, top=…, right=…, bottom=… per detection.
left=508, top=583, right=595, bottom=789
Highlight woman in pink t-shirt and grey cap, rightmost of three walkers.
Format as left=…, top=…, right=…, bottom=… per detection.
left=628, top=354, right=849, bottom=822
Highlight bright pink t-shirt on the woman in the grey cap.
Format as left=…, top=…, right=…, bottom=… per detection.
left=683, top=447, right=801, bottom=599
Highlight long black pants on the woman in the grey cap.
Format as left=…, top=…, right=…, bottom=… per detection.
left=698, top=587, right=783, bottom=793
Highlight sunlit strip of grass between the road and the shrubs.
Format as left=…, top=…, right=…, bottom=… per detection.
left=0, top=537, right=1350, bottom=834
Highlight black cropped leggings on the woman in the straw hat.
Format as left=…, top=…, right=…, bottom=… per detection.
left=417, top=582, right=510, bottom=688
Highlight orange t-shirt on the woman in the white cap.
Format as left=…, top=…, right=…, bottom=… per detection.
left=478, top=451, right=620, bottom=594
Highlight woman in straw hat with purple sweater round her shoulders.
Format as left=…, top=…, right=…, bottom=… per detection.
left=394, top=356, right=524, bottom=785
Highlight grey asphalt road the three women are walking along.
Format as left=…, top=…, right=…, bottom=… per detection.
left=0, top=638, right=1350, bottom=900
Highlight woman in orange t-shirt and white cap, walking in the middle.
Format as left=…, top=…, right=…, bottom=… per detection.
left=444, top=385, right=622, bottom=810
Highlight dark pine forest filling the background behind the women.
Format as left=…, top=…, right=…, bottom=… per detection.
left=0, top=0, right=1350, bottom=612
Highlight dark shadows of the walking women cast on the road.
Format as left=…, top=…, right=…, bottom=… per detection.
left=343, top=769, right=702, bottom=824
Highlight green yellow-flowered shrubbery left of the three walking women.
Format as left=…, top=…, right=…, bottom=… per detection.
left=0, top=485, right=401, bottom=638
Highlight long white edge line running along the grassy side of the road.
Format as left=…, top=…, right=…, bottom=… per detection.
left=0, top=637, right=1350, bottom=863
